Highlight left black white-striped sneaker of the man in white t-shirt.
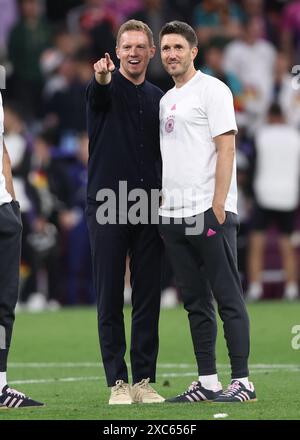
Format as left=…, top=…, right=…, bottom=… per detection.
left=165, top=382, right=222, bottom=403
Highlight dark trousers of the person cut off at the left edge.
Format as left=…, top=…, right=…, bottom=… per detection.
left=0, top=201, right=22, bottom=371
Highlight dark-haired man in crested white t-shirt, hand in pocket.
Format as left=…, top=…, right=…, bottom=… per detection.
left=159, top=21, right=256, bottom=403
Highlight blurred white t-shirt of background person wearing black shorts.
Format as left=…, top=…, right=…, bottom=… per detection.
left=254, top=124, right=300, bottom=211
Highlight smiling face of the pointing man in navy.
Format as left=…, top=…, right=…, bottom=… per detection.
left=116, top=31, right=155, bottom=84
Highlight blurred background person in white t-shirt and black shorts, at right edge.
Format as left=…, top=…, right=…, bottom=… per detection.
left=248, top=104, right=300, bottom=300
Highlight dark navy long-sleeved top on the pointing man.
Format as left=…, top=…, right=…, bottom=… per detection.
left=87, top=70, right=163, bottom=203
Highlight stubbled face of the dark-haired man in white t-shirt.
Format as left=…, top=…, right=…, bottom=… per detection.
left=160, top=34, right=198, bottom=82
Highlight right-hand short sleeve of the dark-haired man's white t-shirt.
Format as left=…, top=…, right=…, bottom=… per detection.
left=205, top=81, right=238, bottom=138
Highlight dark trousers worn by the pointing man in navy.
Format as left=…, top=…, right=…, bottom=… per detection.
left=87, top=204, right=162, bottom=386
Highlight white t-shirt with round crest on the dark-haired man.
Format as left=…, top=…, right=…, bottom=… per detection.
left=159, top=71, right=237, bottom=217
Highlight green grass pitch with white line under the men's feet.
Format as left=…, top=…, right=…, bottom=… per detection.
left=0, top=301, right=300, bottom=421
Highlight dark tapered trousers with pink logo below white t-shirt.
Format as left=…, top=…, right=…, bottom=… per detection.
left=159, top=208, right=250, bottom=378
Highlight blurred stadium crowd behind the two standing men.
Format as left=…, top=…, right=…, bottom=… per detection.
left=0, top=0, right=300, bottom=310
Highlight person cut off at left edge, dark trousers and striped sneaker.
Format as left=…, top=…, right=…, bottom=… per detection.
left=0, top=92, right=43, bottom=409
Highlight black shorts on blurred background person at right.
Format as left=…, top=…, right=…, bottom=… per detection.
left=251, top=205, right=296, bottom=235
